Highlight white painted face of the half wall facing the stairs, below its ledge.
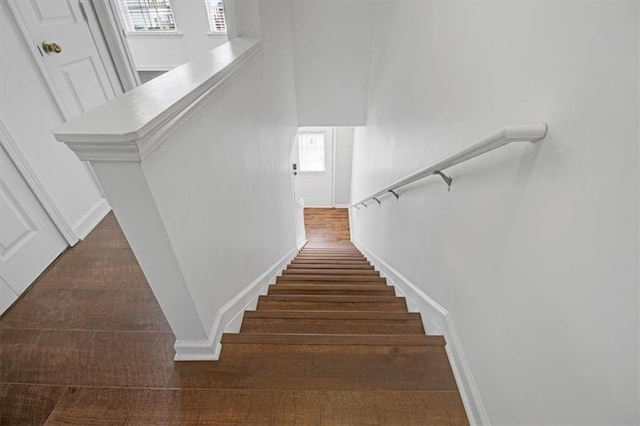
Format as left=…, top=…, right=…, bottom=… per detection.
left=143, top=3, right=297, bottom=331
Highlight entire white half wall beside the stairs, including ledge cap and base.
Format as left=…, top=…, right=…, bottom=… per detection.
left=55, top=3, right=301, bottom=360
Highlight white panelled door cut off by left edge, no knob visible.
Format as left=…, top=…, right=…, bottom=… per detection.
left=0, top=147, right=67, bottom=313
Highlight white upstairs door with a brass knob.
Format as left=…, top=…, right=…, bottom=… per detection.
left=9, top=0, right=120, bottom=120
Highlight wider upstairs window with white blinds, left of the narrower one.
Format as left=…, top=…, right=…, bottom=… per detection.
left=119, top=0, right=176, bottom=33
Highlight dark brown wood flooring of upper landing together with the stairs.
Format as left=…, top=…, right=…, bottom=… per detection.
left=0, top=209, right=467, bottom=426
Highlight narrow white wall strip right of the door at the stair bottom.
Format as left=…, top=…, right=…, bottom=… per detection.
left=333, top=127, right=353, bottom=207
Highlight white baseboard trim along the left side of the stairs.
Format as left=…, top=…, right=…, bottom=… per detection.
left=173, top=245, right=306, bottom=361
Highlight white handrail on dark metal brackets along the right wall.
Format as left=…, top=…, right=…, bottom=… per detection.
left=351, top=123, right=547, bottom=207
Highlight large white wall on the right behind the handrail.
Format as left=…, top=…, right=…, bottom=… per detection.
left=352, top=2, right=640, bottom=424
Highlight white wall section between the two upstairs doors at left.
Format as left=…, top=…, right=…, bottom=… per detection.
left=0, top=2, right=106, bottom=243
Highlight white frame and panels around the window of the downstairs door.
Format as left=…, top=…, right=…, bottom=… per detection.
left=292, top=127, right=334, bottom=207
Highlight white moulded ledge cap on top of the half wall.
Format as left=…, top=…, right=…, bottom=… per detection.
left=53, top=38, right=262, bottom=162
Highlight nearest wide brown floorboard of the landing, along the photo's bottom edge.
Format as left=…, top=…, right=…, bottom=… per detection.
left=43, top=388, right=467, bottom=426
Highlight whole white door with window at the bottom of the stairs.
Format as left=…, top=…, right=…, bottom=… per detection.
left=292, top=127, right=334, bottom=207
